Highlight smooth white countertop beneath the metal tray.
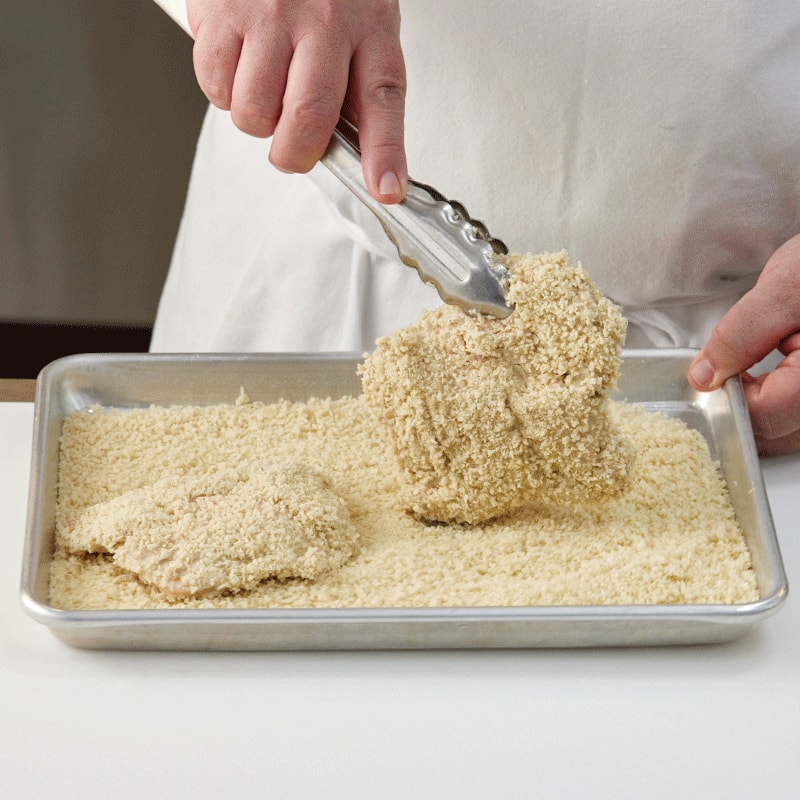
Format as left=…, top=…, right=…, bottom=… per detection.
left=0, top=403, right=800, bottom=800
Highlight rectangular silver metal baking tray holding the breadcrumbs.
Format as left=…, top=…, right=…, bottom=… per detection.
left=21, top=349, right=788, bottom=650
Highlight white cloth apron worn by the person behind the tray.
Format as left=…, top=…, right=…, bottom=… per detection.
left=151, top=0, right=800, bottom=352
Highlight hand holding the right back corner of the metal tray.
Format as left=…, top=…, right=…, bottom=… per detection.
left=689, top=236, right=800, bottom=455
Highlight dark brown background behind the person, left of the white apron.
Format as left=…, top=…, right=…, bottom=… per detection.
left=0, top=0, right=207, bottom=378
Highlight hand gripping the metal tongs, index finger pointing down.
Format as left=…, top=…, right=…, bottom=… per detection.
left=186, top=0, right=408, bottom=203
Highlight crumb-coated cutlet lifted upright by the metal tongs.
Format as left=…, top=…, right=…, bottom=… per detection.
left=359, top=252, right=631, bottom=524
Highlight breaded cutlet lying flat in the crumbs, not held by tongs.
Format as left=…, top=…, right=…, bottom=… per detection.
left=62, top=462, right=358, bottom=597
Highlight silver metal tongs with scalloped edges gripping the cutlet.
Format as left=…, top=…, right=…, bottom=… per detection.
left=321, top=117, right=512, bottom=319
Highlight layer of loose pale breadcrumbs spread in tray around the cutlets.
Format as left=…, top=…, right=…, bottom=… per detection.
left=50, top=378, right=758, bottom=609
